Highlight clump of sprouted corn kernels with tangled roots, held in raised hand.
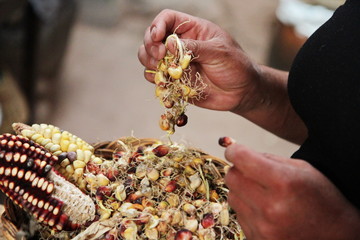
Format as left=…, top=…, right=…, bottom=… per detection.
left=147, top=22, right=206, bottom=134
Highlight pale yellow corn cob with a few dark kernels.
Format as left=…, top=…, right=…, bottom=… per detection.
left=12, top=123, right=102, bottom=189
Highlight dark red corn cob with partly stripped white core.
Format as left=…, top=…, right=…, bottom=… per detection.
left=0, top=134, right=95, bottom=231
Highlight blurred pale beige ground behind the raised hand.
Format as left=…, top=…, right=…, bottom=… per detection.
left=36, top=0, right=297, bottom=161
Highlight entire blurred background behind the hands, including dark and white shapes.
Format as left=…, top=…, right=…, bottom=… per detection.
left=0, top=0, right=343, bottom=160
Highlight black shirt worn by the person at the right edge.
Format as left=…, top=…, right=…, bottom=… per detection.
left=288, top=0, right=360, bottom=208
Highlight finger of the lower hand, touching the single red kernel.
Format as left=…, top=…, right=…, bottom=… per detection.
left=225, top=144, right=281, bottom=186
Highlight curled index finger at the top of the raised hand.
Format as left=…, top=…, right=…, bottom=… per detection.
left=150, top=9, right=195, bottom=42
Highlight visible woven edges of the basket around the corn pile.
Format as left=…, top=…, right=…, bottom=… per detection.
left=1, top=137, right=228, bottom=240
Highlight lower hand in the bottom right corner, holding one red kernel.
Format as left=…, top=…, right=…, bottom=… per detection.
left=225, top=144, right=360, bottom=240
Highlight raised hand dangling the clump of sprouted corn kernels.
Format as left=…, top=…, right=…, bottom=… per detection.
left=138, top=10, right=259, bottom=111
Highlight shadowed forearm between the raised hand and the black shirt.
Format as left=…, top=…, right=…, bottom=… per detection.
left=233, top=66, right=307, bottom=144
